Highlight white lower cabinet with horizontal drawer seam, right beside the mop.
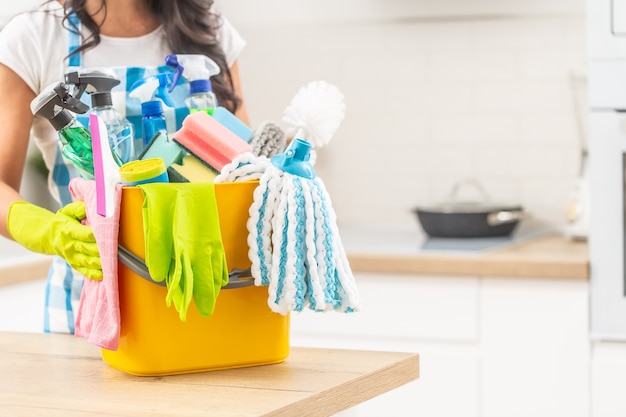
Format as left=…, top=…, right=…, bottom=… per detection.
left=291, top=273, right=480, bottom=417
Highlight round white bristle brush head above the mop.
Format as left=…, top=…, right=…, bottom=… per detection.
left=283, top=81, right=346, bottom=148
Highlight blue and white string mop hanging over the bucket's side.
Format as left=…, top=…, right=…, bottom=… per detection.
left=216, top=139, right=361, bottom=314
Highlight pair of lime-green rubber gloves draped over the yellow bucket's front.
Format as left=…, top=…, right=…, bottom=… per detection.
left=140, top=183, right=228, bottom=321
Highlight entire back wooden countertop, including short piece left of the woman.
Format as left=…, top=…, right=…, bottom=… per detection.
left=0, top=224, right=589, bottom=287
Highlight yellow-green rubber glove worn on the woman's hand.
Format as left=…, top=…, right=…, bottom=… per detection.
left=7, top=201, right=102, bottom=280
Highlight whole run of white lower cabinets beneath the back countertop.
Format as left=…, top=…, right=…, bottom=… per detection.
left=291, top=273, right=588, bottom=417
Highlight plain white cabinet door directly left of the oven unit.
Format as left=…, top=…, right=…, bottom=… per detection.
left=480, top=278, right=588, bottom=417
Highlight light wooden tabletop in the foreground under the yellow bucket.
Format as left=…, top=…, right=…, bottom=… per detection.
left=0, top=332, right=419, bottom=417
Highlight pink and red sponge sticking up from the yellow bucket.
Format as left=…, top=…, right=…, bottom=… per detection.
left=174, top=112, right=252, bottom=171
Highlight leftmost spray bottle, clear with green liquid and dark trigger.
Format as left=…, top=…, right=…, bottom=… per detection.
left=30, top=83, right=94, bottom=179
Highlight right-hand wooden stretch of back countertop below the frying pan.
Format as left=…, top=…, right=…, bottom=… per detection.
left=346, top=229, right=589, bottom=280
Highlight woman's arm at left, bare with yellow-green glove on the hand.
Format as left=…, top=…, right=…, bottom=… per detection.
left=0, top=65, right=102, bottom=279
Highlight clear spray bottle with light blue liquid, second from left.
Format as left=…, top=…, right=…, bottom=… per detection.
left=65, top=69, right=135, bottom=165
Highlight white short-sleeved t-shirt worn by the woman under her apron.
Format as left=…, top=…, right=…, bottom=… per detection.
left=0, top=2, right=245, bottom=198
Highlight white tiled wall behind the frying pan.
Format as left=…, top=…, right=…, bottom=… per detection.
left=222, top=1, right=586, bottom=225
